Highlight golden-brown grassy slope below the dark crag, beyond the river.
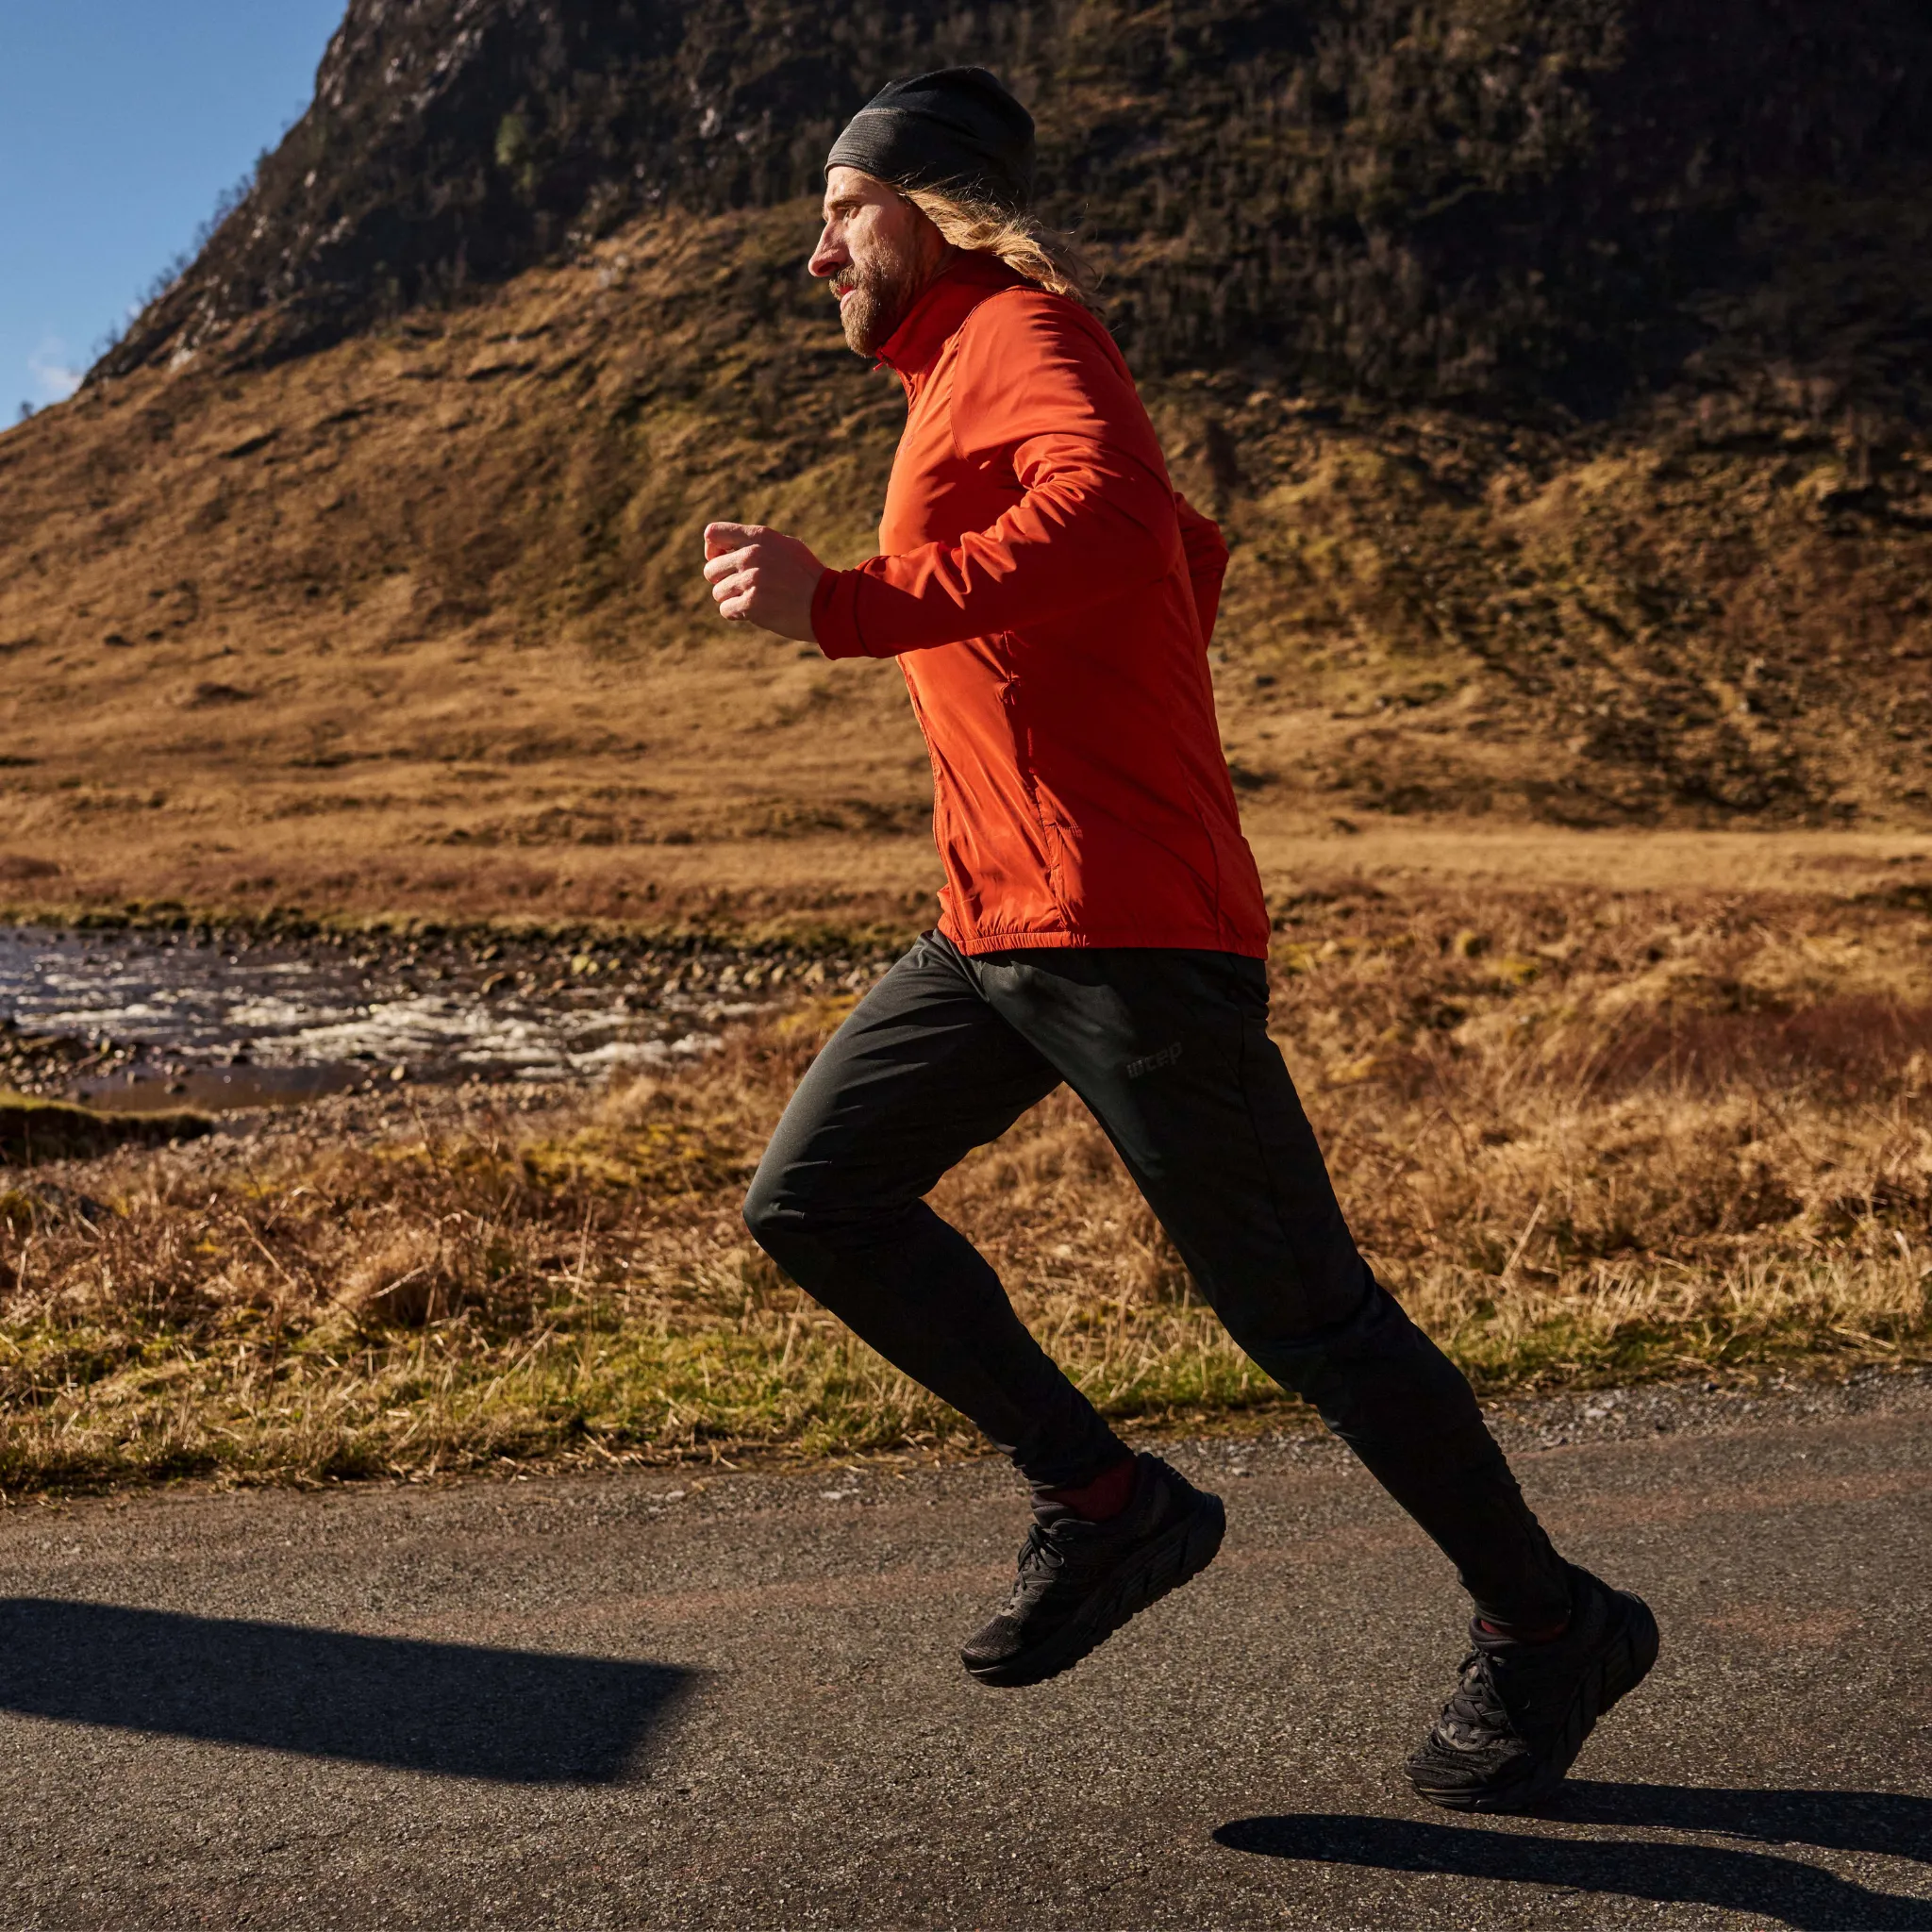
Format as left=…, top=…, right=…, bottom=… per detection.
left=0, top=205, right=1932, bottom=927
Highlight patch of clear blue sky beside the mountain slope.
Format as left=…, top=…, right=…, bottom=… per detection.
left=0, top=0, right=346, bottom=429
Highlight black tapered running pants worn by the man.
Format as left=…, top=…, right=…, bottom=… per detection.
left=746, top=933, right=1569, bottom=1626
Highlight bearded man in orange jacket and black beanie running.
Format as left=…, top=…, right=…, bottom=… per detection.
left=706, top=68, right=1657, bottom=1810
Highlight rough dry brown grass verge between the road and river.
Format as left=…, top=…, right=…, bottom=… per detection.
left=0, top=877, right=1932, bottom=1486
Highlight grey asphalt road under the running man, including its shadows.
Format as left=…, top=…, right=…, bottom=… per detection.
left=0, top=1379, right=1932, bottom=1928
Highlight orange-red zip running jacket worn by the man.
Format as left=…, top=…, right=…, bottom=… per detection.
left=811, top=255, right=1267, bottom=957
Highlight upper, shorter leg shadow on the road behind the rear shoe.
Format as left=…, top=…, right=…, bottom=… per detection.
left=1543, top=1777, right=1932, bottom=1862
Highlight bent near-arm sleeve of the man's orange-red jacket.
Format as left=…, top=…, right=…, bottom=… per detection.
left=811, top=290, right=1174, bottom=657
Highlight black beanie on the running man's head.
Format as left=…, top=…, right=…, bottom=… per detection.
left=824, top=68, right=1034, bottom=210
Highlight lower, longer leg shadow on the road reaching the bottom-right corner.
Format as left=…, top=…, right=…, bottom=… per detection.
left=1215, top=1816, right=1932, bottom=1932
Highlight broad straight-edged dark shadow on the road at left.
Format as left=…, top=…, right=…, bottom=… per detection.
left=0, top=1598, right=693, bottom=1785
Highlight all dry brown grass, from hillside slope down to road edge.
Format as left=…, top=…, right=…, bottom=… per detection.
left=0, top=170, right=1932, bottom=1484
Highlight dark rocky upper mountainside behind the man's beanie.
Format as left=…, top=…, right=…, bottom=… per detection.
left=96, top=0, right=1932, bottom=413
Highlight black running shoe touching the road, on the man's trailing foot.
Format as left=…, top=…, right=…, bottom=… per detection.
left=1408, top=1565, right=1657, bottom=1812
